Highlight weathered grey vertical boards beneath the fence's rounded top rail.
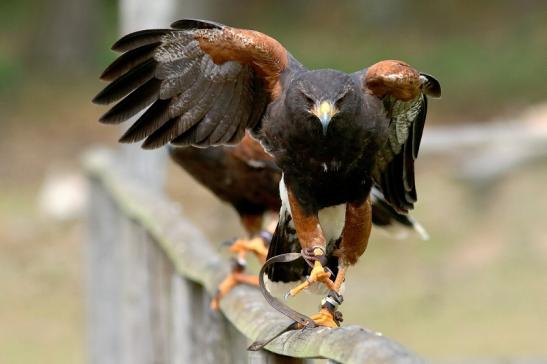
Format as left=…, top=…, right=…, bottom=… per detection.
left=87, top=173, right=253, bottom=364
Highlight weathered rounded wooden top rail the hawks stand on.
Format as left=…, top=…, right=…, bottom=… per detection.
left=85, top=152, right=422, bottom=363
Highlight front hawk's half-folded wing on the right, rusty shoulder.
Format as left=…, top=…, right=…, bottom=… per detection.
left=363, top=61, right=441, bottom=212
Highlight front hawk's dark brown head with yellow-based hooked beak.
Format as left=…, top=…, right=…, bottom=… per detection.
left=287, top=70, right=360, bottom=136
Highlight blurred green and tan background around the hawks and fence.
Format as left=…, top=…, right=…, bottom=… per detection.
left=0, top=0, right=547, bottom=364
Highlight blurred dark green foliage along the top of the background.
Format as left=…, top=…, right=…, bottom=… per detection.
left=0, top=0, right=547, bottom=122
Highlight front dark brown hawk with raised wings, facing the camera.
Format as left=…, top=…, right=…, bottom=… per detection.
left=94, top=20, right=441, bottom=327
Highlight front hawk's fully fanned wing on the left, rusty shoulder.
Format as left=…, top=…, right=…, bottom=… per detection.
left=93, top=20, right=294, bottom=149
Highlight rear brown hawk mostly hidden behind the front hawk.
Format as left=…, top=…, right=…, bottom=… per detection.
left=169, top=135, right=281, bottom=310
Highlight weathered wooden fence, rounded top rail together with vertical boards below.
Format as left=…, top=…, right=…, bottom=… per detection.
left=84, top=151, right=423, bottom=364
